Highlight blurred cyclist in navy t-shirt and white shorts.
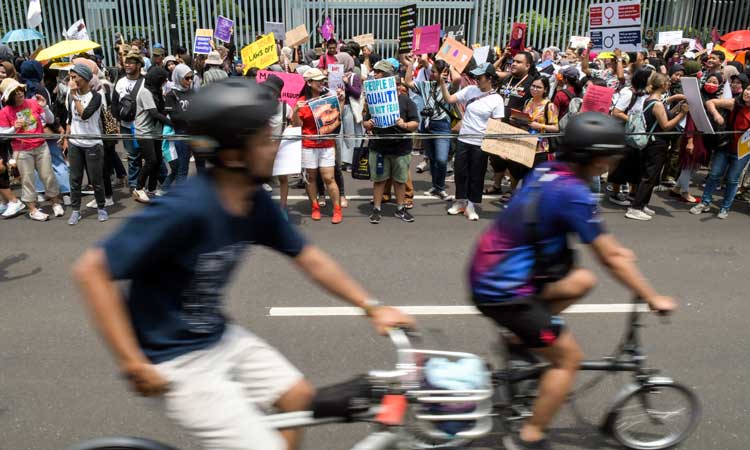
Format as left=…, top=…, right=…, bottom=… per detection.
left=74, top=77, right=412, bottom=450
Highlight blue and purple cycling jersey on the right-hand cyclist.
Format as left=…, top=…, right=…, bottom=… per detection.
left=469, top=161, right=604, bottom=303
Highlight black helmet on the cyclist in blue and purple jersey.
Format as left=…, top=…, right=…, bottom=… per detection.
left=561, top=112, right=626, bottom=162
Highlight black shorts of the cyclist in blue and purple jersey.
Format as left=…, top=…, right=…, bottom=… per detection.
left=475, top=297, right=565, bottom=348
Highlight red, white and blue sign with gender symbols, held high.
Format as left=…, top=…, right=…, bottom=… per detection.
left=589, top=0, right=641, bottom=52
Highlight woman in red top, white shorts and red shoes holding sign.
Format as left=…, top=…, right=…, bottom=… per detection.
left=292, top=69, right=344, bottom=224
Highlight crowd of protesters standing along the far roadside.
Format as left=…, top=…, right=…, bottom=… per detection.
left=0, top=28, right=750, bottom=225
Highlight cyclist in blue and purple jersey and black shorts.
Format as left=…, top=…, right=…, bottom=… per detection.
left=469, top=113, right=676, bottom=449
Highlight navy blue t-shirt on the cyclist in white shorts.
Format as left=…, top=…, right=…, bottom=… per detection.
left=100, top=175, right=305, bottom=364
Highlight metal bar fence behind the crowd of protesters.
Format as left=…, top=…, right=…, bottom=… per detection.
left=0, top=0, right=750, bottom=65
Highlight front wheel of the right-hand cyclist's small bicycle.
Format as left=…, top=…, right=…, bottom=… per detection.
left=607, top=380, right=701, bottom=450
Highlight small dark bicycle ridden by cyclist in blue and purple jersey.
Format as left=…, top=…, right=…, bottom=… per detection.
left=493, top=298, right=701, bottom=450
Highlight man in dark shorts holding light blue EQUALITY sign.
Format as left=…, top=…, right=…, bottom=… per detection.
left=362, top=61, right=419, bottom=223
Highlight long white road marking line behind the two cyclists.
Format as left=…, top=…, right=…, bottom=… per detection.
left=268, top=303, right=648, bottom=317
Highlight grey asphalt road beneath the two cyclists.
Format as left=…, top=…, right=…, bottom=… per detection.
left=0, top=166, right=750, bottom=450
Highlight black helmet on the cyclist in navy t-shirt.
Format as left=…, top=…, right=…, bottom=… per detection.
left=185, top=77, right=279, bottom=153
